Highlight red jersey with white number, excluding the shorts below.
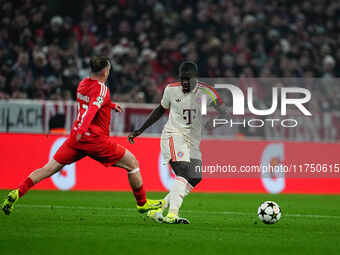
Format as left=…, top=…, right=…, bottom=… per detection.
left=70, top=78, right=115, bottom=142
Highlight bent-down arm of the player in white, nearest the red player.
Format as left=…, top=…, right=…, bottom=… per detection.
left=128, top=87, right=170, bottom=144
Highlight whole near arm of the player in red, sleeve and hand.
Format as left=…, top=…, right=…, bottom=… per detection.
left=76, top=85, right=107, bottom=141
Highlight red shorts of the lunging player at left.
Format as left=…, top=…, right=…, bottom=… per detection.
left=53, top=137, right=126, bottom=167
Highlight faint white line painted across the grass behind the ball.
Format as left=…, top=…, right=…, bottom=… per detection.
left=17, top=204, right=340, bottom=219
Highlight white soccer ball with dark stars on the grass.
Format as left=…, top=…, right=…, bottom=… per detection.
left=257, top=201, right=281, bottom=224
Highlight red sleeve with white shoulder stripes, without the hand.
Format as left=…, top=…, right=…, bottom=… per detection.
left=78, top=84, right=108, bottom=135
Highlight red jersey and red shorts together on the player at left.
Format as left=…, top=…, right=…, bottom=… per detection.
left=53, top=78, right=126, bottom=167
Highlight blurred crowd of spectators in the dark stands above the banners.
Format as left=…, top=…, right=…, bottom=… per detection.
left=0, top=0, right=340, bottom=111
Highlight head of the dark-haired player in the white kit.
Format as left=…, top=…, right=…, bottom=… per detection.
left=179, top=61, right=198, bottom=93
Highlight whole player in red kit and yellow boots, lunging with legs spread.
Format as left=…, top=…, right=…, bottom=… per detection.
left=2, top=56, right=164, bottom=215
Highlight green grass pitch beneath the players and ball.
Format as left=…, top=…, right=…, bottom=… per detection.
left=0, top=190, right=340, bottom=255
